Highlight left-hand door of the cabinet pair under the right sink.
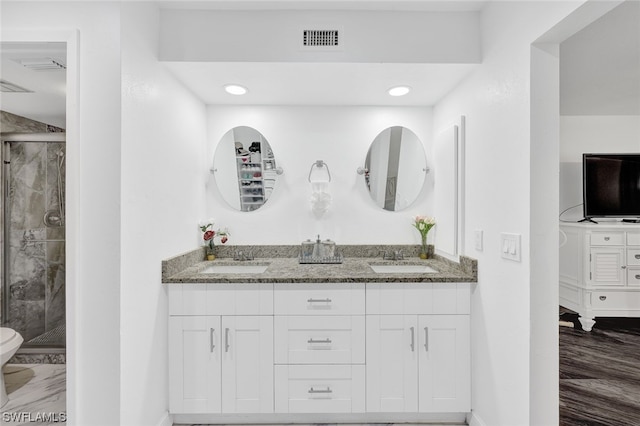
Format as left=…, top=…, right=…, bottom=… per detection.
left=366, top=315, right=418, bottom=412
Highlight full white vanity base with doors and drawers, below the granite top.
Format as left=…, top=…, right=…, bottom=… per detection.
left=168, top=283, right=471, bottom=423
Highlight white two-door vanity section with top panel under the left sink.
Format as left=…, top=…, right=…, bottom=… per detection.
left=169, top=284, right=273, bottom=413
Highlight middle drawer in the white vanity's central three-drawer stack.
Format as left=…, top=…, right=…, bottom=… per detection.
left=274, top=315, right=365, bottom=364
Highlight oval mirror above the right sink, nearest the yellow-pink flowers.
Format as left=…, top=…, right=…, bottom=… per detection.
left=364, top=126, right=427, bottom=211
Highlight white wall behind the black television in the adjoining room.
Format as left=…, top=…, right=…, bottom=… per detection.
left=560, top=115, right=640, bottom=220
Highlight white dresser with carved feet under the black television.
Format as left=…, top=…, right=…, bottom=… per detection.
left=559, top=222, right=640, bottom=331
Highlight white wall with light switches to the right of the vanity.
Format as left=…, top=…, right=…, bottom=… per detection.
left=434, top=2, right=579, bottom=426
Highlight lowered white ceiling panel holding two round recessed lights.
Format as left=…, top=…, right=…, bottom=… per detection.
left=164, top=62, right=479, bottom=106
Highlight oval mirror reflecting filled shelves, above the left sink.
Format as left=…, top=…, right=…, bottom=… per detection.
left=213, top=126, right=277, bottom=212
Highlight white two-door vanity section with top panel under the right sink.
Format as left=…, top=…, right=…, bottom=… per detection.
left=366, top=283, right=471, bottom=413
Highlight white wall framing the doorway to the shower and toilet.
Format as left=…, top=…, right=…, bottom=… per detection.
left=0, top=1, right=120, bottom=426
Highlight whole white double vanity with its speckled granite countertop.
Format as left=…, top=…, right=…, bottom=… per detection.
left=162, top=246, right=477, bottom=423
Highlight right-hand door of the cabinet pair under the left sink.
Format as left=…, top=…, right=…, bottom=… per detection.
left=221, top=316, right=273, bottom=413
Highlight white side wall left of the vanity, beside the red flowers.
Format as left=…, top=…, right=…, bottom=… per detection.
left=120, top=3, right=210, bottom=426
